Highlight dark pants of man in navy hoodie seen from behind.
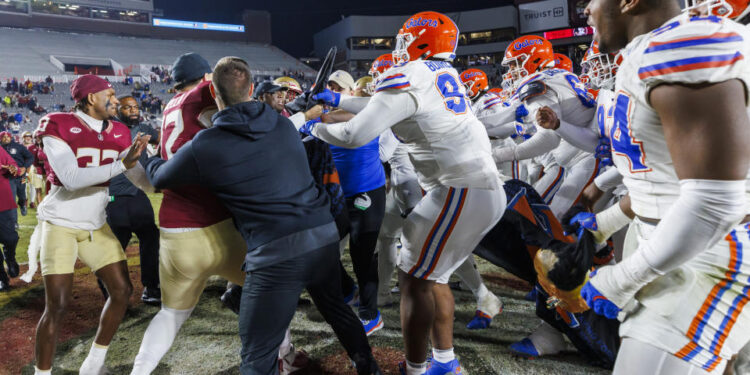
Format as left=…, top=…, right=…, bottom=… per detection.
left=239, top=243, right=376, bottom=375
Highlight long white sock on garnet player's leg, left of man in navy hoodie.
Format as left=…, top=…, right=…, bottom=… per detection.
left=130, top=307, right=193, bottom=375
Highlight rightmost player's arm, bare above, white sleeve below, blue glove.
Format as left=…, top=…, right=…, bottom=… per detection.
left=582, top=79, right=750, bottom=318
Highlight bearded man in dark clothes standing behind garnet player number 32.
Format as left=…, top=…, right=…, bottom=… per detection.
left=107, top=96, right=161, bottom=305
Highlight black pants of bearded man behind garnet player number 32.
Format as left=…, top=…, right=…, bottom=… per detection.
left=107, top=190, right=159, bottom=288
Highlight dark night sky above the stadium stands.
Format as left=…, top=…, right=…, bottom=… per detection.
left=154, top=0, right=512, bottom=57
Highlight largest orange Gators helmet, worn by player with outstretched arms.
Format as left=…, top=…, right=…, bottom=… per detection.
left=393, top=12, right=458, bottom=64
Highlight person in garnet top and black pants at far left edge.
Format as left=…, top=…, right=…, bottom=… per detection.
left=0, top=145, right=18, bottom=292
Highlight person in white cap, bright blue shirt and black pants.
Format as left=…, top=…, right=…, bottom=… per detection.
left=328, top=70, right=385, bottom=335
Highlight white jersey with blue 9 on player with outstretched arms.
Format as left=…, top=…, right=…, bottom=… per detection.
left=375, top=60, right=502, bottom=190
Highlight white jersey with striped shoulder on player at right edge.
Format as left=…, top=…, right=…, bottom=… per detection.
left=609, top=15, right=750, bottom=219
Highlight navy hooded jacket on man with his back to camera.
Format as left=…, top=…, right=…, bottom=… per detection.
left=146, top=102, right=339, bottom=272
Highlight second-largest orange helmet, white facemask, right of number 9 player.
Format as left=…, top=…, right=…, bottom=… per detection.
left=502, top=35, right=555, bottom=89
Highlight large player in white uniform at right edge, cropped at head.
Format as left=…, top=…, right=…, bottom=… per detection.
left=581, top=0, right=750, bottom=374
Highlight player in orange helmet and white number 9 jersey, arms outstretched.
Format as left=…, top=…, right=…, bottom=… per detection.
left=301, top=12, right=506, bottom=375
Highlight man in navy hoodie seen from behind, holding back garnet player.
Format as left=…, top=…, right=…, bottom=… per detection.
left=146, top=57, right=380, bottom=375
